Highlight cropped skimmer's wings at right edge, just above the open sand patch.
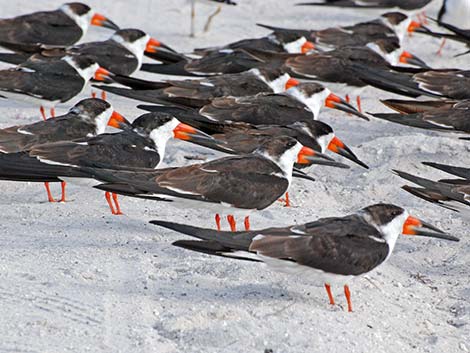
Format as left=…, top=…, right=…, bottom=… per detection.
left=372, top=100, right=470, bottom=134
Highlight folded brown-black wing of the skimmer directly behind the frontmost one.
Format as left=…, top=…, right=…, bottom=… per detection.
left=90, top=156, right=288, bottom=209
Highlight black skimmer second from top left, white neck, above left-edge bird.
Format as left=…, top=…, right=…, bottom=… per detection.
left=0, top=28, right=172, bottom=76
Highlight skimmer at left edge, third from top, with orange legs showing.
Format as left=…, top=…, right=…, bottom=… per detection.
left=0, top=55, right=109, bottom=120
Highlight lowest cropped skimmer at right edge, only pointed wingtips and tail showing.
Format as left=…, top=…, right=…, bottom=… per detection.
left=395, top=168, right=470, bottom=219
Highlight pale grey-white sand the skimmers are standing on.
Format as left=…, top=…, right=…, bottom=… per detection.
left=0, top=0, right=470, bottom=353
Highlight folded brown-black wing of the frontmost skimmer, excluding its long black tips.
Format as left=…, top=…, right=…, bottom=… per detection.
left=250, top=216, right=389, bottom=275
